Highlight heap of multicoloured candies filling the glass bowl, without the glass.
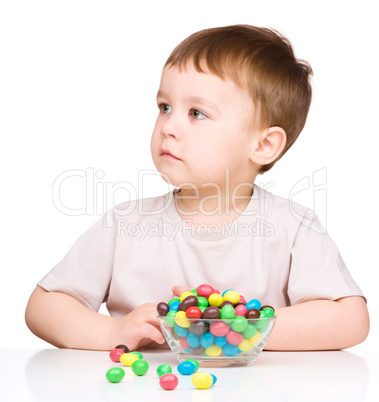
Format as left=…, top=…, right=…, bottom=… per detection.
left=157, top=284, right=275, bottom=357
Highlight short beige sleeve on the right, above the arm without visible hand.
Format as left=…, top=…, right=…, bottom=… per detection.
left=288, top=211, right=364, bottom=305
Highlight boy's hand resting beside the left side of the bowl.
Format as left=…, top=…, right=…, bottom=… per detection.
left=112, top=303, right=165, bottom=351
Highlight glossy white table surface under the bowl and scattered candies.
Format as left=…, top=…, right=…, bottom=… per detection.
left=0, top=349, right=379, bottom=402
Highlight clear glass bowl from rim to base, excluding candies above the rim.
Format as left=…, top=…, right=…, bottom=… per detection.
left=157, top=315, right=276, bottom=367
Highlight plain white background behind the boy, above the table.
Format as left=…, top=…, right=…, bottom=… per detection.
left=0, top=0, right=379, bottom=350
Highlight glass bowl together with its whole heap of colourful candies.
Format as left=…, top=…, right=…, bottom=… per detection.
left=157, top=284, right=276, bottom=367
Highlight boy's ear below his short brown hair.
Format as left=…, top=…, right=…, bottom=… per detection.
left=250, top=127, right=287, bottom=165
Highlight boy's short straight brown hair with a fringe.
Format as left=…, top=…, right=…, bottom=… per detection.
left=164, top=25, right=313, bottom=173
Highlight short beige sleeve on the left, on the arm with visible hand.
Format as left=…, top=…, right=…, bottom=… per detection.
left=38, top=210, right=116, bottom=311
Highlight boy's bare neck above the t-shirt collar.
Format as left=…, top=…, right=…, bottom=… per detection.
left=174, top=183, right=253, bottom=228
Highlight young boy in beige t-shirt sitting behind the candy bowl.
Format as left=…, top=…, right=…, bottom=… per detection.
left=26, top=25, right=369, bottom=350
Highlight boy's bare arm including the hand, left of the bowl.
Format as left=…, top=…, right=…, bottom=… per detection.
left=25, top=286, right=164, bottom=350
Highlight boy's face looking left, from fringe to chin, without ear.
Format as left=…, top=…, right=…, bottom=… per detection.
left=151, top=62, right=255, bottom=191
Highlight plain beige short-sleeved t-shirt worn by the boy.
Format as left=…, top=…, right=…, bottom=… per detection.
left=38, top=185, right=363, bottom=318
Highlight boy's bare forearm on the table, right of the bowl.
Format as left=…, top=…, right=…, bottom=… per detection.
left=265, top=296, right=370, bottom=351
